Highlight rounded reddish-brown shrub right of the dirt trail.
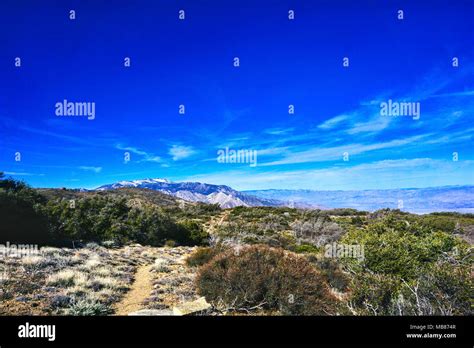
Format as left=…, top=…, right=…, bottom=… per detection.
left=196, top=245, right=337, bottom=315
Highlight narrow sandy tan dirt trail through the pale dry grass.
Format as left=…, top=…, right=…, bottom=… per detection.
left=115, top=265, right=153, bottom=315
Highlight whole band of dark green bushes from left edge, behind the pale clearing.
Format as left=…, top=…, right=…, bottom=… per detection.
left=0, top=178, right=208, bottom=246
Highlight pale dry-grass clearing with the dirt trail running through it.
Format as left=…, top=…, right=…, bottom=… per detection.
left=0, top=244, right=209, bottom=315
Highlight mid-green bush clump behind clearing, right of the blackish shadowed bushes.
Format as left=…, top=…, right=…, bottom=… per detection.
left=43, top=194, right=208, bottom=246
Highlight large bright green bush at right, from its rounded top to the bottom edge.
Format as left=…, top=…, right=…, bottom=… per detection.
left=342, top=220, right=472, bottom=315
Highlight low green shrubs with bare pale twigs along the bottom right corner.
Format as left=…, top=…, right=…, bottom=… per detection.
left=349, top=264, right=473, bottom=315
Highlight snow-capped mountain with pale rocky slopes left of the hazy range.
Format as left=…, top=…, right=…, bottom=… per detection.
left=96, top=179, right=284, bottom=208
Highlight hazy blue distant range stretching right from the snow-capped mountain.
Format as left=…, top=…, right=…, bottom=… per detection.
left=245, top=186, right=474, bottom=214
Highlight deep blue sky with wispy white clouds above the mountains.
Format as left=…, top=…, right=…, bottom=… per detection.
left=0, top=0, right=474, bottom=190
